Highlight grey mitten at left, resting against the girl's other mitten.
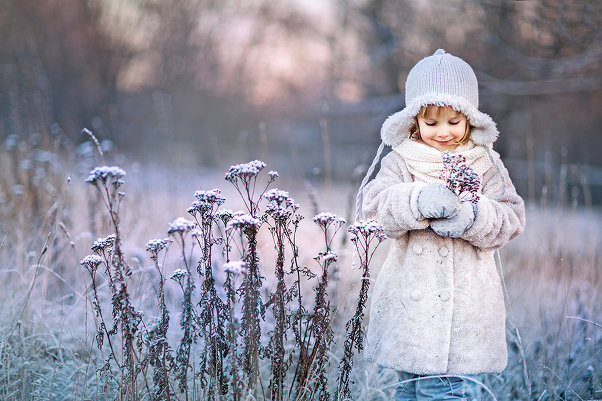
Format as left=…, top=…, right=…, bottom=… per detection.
left=418, top=182, right=461, bottom=219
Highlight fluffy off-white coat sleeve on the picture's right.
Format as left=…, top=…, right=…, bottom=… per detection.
left=461, top=152, right=525, bottom=249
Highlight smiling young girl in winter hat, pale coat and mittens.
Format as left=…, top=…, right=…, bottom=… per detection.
left=358, top=49, right=525, bottom=400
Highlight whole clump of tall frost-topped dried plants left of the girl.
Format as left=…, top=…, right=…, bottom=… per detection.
left=80, top=160, right=384, bottom=401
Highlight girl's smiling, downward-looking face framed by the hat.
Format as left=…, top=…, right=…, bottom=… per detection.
left=418, top=107, right=468, bottom=152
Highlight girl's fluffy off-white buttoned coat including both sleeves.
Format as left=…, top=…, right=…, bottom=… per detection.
left=363, top=145, right=525, bottom=374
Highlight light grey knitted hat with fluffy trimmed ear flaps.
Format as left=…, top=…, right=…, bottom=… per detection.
left=380, top=49, right=498, bottom=146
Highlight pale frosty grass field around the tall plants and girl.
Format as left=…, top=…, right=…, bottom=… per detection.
left=0, top=139, right=602, bottom=401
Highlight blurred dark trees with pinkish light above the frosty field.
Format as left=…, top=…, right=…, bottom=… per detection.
left=0, top=0, right=602, bottom=205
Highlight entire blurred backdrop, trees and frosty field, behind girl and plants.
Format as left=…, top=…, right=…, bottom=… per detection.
left=0, top=0, right=602, bottom=401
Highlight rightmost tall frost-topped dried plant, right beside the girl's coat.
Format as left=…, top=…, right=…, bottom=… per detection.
left=334, top=219, right=386, bottom=400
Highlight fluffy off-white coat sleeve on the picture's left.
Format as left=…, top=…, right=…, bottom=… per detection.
left=362, top=152, right=429, bottom=238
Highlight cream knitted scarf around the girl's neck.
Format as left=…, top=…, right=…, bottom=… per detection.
left=393, top=139, right=493, bottom=183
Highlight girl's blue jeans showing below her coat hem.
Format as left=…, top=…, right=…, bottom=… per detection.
left=394, top=372, right=482, bottom=401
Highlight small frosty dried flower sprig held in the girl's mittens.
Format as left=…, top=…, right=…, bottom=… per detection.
left=440, top=151, right=481, bottom=204
